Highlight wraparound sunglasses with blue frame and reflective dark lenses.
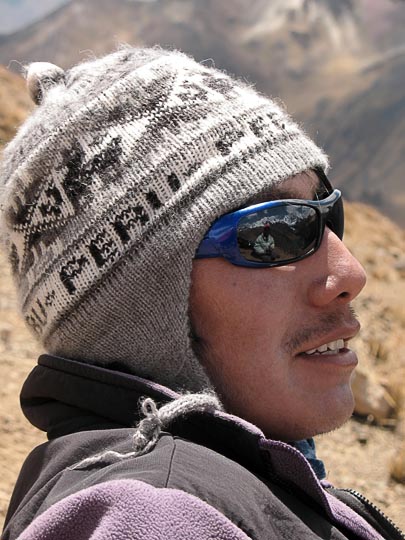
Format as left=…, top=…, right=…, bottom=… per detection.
left=195, top=189, right=344, bottom=268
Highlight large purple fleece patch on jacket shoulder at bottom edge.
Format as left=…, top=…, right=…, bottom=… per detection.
left=18, top=480, right=249, bottom=540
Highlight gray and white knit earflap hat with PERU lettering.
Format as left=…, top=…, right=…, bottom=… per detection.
left=0, top=47, right=327, bottom=391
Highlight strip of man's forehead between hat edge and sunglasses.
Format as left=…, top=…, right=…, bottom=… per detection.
left=246, top=170, right=325, bottom=206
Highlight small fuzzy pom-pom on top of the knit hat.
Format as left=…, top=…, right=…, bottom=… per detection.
left=26, top=62, right=65, bottom=105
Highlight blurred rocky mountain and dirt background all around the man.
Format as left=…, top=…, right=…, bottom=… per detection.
left=0, top=0, right=405, bottom=529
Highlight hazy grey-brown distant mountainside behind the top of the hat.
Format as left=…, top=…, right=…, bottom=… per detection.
left=0, top=0, right=405, bottom=226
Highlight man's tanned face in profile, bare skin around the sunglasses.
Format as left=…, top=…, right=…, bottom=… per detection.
left=190, top=172, right=366, bottom=441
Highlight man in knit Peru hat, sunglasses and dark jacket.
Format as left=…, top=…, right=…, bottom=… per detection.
left=2, top=48, right=403, bottom=540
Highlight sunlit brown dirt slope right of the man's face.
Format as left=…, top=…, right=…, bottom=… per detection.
left=317, top=203, right=405, bottom=530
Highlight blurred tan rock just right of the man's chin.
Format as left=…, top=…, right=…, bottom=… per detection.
left=352, top=369, right=396, bottom=424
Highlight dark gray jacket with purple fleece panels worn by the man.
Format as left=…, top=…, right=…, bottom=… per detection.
left=2, top=355, right=405, bottom=540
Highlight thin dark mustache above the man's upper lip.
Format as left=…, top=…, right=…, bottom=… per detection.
left=285, top=306, right=358, bottom=354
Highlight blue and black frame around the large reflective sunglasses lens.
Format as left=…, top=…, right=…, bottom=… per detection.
left=195, top=189, right=344, bottom=268
